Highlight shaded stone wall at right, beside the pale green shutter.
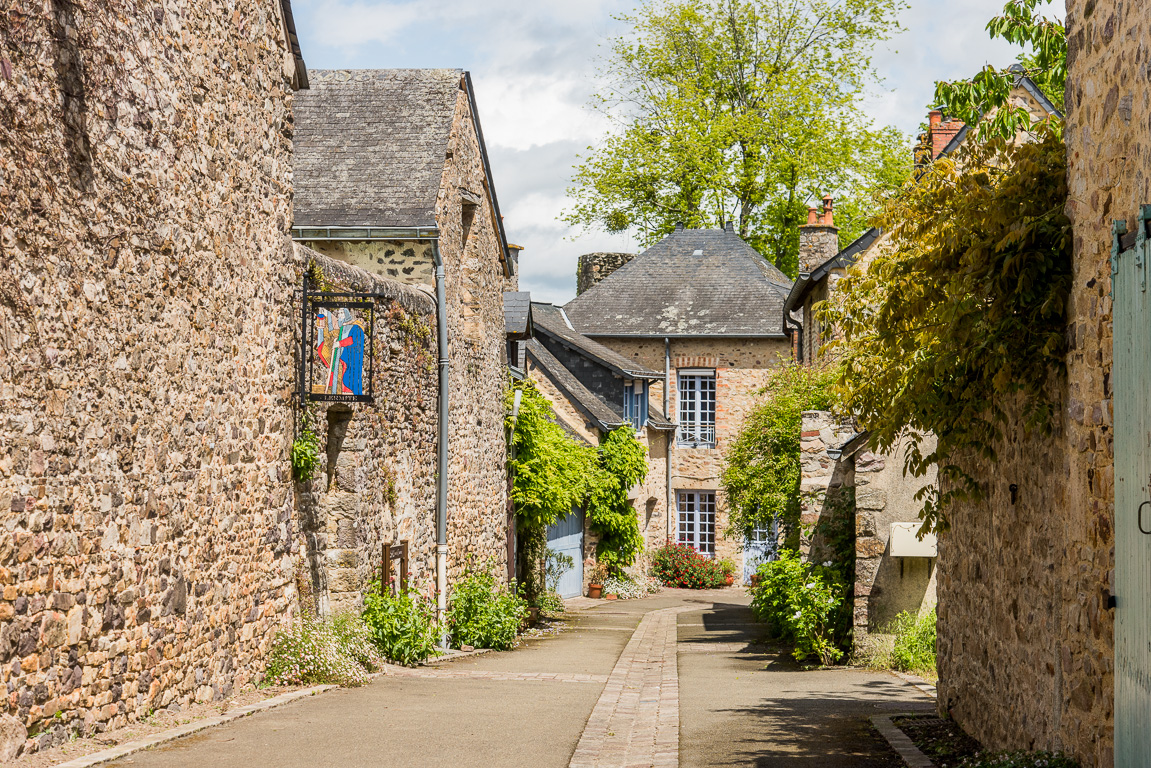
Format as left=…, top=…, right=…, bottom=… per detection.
left=939, top=0, right=1151, bottom=766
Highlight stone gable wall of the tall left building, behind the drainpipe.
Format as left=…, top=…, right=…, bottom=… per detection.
left=302, top=70, right=518, bottom=584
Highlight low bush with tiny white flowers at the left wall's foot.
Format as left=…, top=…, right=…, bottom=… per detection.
left=267, top=614, right=382, bottom=685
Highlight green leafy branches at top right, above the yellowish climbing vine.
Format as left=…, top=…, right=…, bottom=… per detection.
left=935, top=0, right=1067, bottom=139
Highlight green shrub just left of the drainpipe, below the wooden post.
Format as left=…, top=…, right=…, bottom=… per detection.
left=364, top=581, right=440, bottom=667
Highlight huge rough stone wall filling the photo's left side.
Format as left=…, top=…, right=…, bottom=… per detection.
left=0, top=0, right=298, bottom=748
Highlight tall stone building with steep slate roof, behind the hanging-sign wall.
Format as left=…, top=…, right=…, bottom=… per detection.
left=292, top=69, right=518, bottom=598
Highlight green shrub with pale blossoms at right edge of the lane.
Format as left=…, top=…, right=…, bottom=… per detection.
left=752, top=549, right=847, bottom=664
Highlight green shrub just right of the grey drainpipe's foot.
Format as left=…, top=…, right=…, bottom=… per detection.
left=448, top=567, right=527, bottom=651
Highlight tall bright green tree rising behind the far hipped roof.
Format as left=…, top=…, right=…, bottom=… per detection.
left=565, top=0, right=910, bottom=275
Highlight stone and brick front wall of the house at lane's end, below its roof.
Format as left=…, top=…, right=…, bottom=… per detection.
left=596, top=337, right=791, bottom=568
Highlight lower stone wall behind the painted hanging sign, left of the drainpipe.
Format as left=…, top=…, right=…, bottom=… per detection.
left=296, top=245, right=439, bottom=616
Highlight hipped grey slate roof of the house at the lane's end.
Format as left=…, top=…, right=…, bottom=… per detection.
left=564, top=229, right=792, bottom=337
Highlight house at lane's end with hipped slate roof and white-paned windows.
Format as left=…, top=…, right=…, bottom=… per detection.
left=564, top=222, right=792, bottom=572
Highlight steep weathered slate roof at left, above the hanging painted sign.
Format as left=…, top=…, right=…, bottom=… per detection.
left=292, top=69, right=464, bottom=227
